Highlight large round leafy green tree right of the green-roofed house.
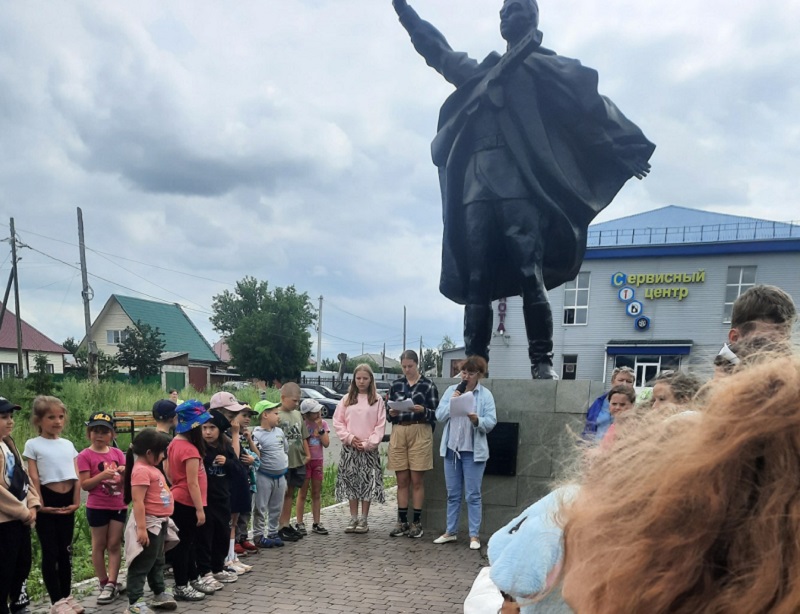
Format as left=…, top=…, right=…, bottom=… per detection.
left=211, top=277, right=316, bottom=382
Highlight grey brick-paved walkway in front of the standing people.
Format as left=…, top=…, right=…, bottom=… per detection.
left=51, top=489, right=488, bottom=614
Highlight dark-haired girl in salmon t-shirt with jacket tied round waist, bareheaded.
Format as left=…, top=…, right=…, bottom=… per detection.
left=125, top=429, right=178, bottom=614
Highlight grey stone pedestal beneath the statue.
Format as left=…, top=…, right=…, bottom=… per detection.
left=422, top=379, right=603, bottom=539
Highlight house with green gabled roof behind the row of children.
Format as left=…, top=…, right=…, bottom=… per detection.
left=84, top=294, right=225, bottom=391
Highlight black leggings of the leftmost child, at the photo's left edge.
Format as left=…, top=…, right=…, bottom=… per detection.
left=0, top=520, right=31, bottom=614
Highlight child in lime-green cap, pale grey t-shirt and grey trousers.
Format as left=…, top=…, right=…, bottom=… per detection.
left=253, top=401, right=289, bottom=548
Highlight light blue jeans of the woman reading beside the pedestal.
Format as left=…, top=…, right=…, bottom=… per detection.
left=444, top=448, right=486, bottom=537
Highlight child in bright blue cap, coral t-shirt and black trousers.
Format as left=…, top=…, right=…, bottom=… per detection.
left=167, top=399, right=215, bottom=601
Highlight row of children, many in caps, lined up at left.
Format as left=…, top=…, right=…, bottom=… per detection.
left=0, top=383, right=346, bottom=614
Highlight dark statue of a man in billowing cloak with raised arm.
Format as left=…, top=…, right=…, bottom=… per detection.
left=393, top=0, right=655, bottom=379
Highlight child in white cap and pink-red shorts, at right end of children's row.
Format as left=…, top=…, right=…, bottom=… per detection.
left=297, top=399, right=331, bottom=535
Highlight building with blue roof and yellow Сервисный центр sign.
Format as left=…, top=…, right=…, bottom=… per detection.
left=444, top=206, right=800, bottom=386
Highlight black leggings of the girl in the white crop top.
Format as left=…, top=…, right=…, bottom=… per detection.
left=36, top=485, right=75, bottom=603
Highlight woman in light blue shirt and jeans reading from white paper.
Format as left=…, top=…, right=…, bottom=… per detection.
left=433, top=356, right=497, bottom=550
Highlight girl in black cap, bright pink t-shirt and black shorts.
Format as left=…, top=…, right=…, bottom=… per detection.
left=78, top=412, right=128, bottom=605
